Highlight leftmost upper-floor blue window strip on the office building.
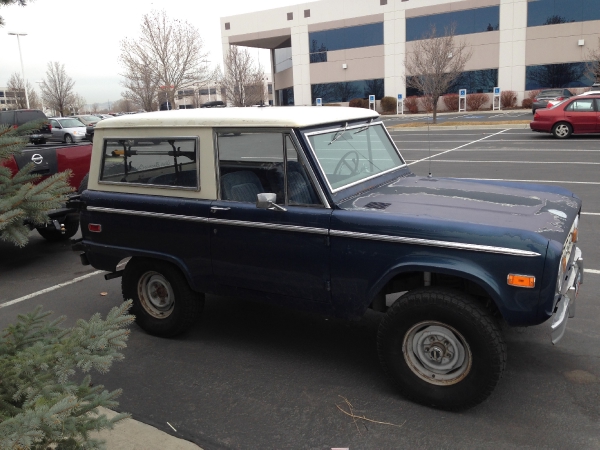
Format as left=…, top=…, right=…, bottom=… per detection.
left=308, top=22, right=383, bottom=63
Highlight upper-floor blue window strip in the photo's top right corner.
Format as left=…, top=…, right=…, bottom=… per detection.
left=527, top=0, right=600, bottom=27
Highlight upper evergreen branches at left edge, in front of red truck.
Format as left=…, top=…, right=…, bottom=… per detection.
left=0, top=121, right=73, bottom=247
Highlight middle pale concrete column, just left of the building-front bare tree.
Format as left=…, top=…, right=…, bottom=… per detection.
left=383, top=9, right=406, bottom=98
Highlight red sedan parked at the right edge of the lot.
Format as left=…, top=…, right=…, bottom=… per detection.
left=529, top=95, right=600, bottom=139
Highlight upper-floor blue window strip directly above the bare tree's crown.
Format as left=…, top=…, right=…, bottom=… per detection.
left=406, top=6, right=500, bottom=41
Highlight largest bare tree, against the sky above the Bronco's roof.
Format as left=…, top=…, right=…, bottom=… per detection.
left=119, top=11, right=207, bottom=110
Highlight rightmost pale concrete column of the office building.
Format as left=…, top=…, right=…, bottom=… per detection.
left=498, top=0, right=527, bottom=104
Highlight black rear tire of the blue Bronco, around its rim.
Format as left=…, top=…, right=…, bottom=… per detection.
left=121, top=258, right=204, bottom=337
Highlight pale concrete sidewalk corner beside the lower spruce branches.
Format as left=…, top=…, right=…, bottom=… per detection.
left=92, top=408, right=202, bottom=450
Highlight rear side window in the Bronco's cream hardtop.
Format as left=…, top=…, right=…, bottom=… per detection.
left=100, top=138, right=200, bottom=190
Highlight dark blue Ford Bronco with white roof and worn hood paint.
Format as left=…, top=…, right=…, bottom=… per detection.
left=70, top=107, right=583, bottom=410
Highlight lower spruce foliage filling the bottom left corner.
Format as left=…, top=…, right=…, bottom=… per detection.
left=0, top=301, right=134, bottom=450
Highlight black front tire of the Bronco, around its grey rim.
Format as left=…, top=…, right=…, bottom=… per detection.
left=377, top=288, right=506, bottom=411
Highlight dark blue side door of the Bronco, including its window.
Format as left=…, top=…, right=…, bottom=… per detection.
left=209, top=131, right=331, bottom=302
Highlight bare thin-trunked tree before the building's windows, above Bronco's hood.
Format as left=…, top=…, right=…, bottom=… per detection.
left=405, top=25, right=473, bottom=123
